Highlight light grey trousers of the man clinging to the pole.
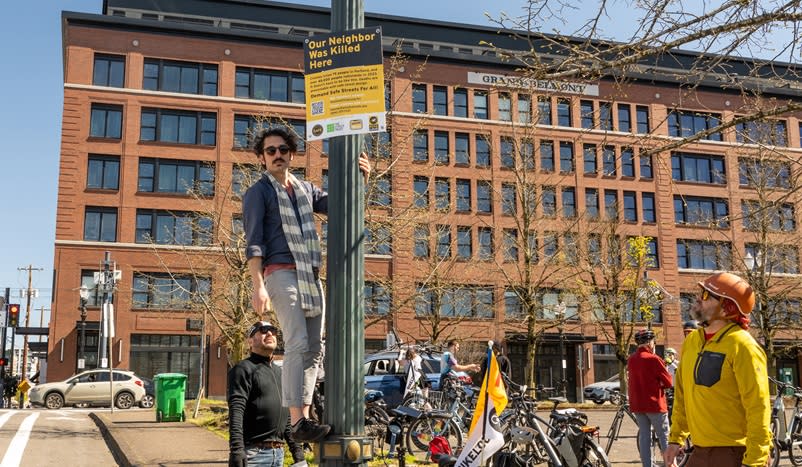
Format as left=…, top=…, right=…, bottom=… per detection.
left=265, top=269, right=326, bottom=407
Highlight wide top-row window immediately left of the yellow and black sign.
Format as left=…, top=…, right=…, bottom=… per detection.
left=235, top=67, right=306, bottom=104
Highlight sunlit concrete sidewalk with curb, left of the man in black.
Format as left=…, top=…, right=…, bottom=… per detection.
left=89, top=409, right=228, bottom=467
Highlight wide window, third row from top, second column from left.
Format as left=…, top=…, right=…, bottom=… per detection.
left=137, top=158, right=214, bottom=196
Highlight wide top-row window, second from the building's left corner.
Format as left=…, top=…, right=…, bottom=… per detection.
left=142, top=58, right=217, bottom=96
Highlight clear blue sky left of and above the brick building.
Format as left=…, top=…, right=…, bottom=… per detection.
left=0, top=0, right=792, bottom=330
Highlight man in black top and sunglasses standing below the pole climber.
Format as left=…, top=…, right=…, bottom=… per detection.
left=228, top=321, right=304, bottom=467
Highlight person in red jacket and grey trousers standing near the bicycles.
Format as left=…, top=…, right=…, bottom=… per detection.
left=627, top=329, right=672, bottom=467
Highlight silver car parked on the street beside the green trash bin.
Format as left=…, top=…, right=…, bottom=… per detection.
left=29, top=369, right=145, bottom=409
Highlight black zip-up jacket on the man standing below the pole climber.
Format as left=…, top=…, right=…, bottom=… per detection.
left=228, top=353, right=294, bottom=452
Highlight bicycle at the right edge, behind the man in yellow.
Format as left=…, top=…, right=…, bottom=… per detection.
left=769, top=377, right=802, bottom=467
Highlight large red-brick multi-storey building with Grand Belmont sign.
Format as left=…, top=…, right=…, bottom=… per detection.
left=48, top=0, right=801, bottom=397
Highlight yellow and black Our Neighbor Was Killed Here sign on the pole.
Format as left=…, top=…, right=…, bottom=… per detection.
left=304, top=28, right=387, bottom=141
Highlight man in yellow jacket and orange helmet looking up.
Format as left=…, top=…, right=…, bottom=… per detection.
left=663, top=272, right=771, bottom=467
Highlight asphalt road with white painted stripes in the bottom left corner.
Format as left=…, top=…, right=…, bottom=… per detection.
left=0, top=408, right=117, bottom=467
